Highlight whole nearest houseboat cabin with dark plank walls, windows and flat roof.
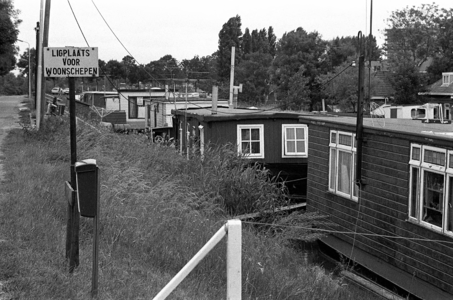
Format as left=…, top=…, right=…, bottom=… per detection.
left=300, top=116, right=453, bottom=299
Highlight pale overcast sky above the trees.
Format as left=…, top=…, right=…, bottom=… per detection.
left=13, top=0, right=453, bottom=64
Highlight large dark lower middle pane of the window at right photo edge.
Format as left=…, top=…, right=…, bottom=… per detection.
left=423, top=171, right=444, bottom=227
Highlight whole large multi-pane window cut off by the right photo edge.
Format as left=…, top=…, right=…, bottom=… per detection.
left=409, top=144, right=453, bottom=235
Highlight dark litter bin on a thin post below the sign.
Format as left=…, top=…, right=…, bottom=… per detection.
left=75, top=159, right=99, bottom=218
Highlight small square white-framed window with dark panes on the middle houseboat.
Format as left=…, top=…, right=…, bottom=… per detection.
left=237, top=125, right=264, bottom=158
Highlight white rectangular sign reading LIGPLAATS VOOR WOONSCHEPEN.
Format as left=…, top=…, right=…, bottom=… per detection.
left=43, top=47, right=99, bottom=77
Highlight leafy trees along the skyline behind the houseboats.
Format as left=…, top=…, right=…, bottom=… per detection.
left=0, top=1, right=453, bottom=111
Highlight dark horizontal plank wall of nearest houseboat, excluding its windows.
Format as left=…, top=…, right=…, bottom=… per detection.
left=307, top=123, right=453, bottom=298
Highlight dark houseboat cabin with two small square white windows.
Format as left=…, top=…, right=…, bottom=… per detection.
left=173, top=108, right=308, bottom=202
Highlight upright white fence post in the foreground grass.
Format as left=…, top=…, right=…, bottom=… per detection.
left=227, top=220, right=242, bottom=300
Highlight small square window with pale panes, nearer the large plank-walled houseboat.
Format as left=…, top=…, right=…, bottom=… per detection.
left=282, top=124, right=308, bottom=157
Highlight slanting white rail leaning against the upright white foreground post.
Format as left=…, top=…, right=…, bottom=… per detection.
left=153, top=225, right=227, bottom=300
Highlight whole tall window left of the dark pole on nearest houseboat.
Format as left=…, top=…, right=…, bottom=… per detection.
left=329, top=130, right=358, bottom=201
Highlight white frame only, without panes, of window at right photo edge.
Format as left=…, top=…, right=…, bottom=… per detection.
left=408, top=144, right=453, bottom=236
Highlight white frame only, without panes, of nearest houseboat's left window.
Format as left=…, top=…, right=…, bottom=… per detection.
left=329, top=130, right=358, bottom=202
